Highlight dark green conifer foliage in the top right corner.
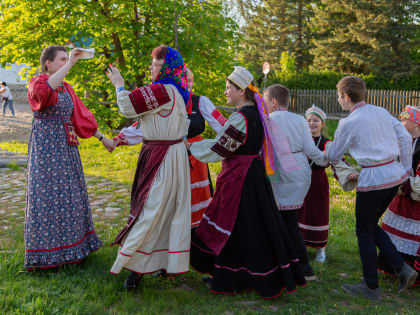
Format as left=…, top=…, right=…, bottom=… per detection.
left=311, top=0, right=420, bottom=74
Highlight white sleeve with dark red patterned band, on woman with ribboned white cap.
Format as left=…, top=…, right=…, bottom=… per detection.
left=190, top=113, right=247, bottom=163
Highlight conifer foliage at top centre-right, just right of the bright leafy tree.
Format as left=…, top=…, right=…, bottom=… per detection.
left=237, top=0, right=315, bottom=70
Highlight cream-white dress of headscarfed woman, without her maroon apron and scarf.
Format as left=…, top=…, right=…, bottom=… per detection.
left=111, top=84, right=191, bottom=274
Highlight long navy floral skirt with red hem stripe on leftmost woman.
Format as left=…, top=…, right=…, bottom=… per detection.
left=25, top=90, right=102, bottom=269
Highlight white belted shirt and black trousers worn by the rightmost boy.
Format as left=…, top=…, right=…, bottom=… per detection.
left=326, top=102, right=412, bottom=290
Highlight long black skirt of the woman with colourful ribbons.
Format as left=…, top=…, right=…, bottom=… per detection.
left=191, top=159, right=306, bottom=298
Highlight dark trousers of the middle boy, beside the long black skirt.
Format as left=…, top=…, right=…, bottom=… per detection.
left=280, top=209, right=309, bottom=269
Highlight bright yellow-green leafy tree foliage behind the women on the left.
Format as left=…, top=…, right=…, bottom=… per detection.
left=0, top=0, right=238, bottom=128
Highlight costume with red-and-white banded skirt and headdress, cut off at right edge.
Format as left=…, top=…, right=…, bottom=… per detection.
left=378, top=106, right=420, bottom=286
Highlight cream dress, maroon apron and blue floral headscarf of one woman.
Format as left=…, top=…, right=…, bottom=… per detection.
left=111, top=47, right=191, bottom=274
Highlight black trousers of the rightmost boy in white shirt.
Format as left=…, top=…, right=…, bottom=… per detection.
left=356, top=186, right=404, bottom=289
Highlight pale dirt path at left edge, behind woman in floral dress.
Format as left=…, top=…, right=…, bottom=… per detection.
left=0, top=103, right=32, bottom=143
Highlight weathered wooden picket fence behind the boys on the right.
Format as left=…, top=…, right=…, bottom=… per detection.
left=217, top=90, right=420, bottom=120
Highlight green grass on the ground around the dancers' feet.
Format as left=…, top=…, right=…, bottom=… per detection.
left=0, top=139, right=420, bottom=314
